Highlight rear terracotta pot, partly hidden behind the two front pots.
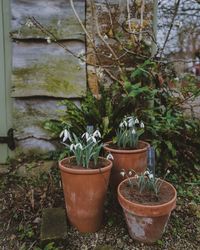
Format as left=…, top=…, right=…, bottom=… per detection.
left=104, top=141, right=150, bottom=190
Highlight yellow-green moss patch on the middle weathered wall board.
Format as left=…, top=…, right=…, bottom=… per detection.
left=13, top=58, right=85, bottom=97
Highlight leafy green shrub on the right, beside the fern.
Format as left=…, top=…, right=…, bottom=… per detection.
left=126, top=60, right=200, bottom=174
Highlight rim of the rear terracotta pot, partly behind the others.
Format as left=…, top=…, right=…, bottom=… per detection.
left=103, top=140, right=150, bottom=154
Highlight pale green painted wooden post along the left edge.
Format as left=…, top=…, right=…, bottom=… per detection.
left=0, top=0, right=9, bottom=163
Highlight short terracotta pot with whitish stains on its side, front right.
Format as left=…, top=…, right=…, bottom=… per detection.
left=118, top=177, right=177, bottom=244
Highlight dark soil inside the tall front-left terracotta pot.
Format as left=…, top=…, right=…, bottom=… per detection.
left=65, top=158, right=108, bottom=169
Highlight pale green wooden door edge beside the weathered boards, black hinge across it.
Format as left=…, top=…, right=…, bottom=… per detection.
left=0, top=0, right=11, bottom=163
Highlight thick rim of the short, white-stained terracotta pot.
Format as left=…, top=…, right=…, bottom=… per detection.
left=117, top=177, right=177, bottom=217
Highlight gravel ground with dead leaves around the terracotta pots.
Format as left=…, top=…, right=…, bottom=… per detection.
left=0, top=162, right=200, bottom=250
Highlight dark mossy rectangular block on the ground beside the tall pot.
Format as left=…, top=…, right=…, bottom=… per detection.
left=40, top=208, right=67, bottom=244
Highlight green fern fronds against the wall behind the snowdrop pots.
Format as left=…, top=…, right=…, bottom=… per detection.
left=44, top=85, right=134, bottom=140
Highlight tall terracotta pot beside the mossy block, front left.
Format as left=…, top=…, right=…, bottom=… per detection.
left=59, top=157, right=112, bottom=233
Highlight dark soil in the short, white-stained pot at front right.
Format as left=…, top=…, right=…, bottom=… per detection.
left=120, top=182, right=174, bottom=205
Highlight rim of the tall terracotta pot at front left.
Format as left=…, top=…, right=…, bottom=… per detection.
left=58, top=156, right=113, bottom=175
